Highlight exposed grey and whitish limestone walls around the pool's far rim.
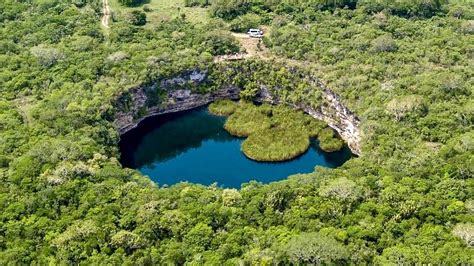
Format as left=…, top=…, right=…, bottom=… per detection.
left=115, top=71, right=361, bottom=155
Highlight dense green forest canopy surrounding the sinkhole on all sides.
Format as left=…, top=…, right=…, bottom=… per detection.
left=0, top=0, right=474, bottom=265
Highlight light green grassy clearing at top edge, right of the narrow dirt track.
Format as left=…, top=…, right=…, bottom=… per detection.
left=110, top=0, right=209, bottom=26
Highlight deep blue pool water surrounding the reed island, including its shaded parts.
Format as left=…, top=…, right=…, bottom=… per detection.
left=120, top=107, right=352, bottom=188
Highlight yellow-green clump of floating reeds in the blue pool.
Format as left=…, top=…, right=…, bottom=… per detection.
left=209, top=100, right=344, bottom=162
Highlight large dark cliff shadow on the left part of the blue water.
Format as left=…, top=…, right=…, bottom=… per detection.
left=120, top=107, right=234, bottom=168
